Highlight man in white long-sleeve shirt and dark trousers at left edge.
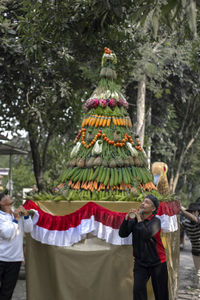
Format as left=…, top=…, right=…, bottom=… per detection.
left=0, top=190, right=33, bottom=300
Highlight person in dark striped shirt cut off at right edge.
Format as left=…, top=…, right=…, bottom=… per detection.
left=181, top=203, right=200, bottom=288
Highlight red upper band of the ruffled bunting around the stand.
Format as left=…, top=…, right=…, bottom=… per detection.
left=24, top=200, right=180, bottom=231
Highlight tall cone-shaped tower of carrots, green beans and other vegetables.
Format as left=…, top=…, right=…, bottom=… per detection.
left=57, top=48, right=156, bottom=200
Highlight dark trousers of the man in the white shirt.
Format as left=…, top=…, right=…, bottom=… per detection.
left=0, top=261, right=21, bottom=300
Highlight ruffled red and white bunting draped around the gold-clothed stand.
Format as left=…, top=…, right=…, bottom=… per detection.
left=24, top=200, right=180, bottom=246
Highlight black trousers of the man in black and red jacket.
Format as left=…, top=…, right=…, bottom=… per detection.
left=133, top=262, right=169, bottom=300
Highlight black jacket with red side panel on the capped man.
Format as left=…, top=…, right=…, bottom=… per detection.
left=119, top=215, right=166, bottom=267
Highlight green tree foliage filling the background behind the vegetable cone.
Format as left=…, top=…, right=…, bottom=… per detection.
left=0, top=0, right=199, bottom=199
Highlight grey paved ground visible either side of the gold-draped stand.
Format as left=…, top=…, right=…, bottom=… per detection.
left=12, top=239, right=200, bottom=300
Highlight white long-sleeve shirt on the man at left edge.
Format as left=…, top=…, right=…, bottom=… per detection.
left=0, top=210, right=33, bottom=262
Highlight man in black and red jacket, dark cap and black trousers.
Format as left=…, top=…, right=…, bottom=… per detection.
left=119, top=194, right=169, bottom=300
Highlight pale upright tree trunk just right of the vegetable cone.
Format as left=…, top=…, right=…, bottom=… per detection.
left=136, top=75, right=146, bottom=147
